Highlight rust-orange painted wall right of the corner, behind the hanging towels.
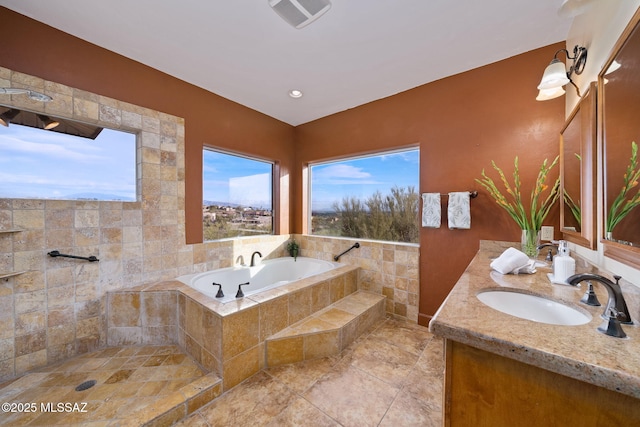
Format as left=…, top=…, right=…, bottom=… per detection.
left=292, top=44, right=564, bottom=324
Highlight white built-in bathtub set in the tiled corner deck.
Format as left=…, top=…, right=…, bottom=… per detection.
left=176, top=257, right=343, bottom=303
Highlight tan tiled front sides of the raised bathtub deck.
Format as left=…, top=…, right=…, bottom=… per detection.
left=107, top=265, right=361, bottom=390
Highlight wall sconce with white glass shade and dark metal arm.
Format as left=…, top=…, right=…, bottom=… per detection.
left=536, top=45, right=587, bottom=101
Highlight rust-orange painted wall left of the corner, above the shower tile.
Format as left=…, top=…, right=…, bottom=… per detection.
left=0, top=7, right=293, bottom=243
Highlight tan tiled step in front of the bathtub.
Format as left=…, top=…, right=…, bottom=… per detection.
left=265, top=291, right=385, bottom=367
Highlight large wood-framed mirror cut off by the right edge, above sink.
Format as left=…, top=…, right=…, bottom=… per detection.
left=598, top=12, right=640, bottom=268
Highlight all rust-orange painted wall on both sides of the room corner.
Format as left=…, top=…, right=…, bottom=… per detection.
left=0, top=7, right=564, bottom=324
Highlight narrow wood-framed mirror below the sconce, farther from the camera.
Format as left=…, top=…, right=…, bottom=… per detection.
left=560, top=82, right=596, bottom=249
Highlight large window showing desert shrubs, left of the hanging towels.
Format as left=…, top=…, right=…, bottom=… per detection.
left=310, top=149, right=420, bottom=243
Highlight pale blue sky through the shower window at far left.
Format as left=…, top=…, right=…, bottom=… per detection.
left=0, top=124, right=136, bottom=200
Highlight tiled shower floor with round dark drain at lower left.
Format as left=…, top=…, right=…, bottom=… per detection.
left=0, top=346, right=219, bottom=426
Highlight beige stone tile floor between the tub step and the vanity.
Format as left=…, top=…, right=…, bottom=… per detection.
left=178, top=319, right=444, bottom=427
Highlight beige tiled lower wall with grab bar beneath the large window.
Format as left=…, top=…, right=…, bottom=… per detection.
left=295, top=235, right=420, bottom=323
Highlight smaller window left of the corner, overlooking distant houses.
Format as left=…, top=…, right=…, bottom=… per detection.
left=202, top=149, right=273, bottom=241
